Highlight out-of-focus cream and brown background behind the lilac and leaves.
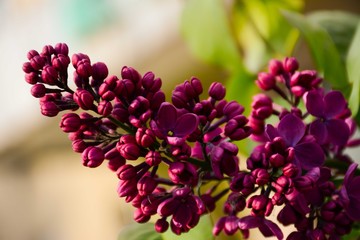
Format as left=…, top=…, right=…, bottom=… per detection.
left=0, top=0, right=360, bottom=240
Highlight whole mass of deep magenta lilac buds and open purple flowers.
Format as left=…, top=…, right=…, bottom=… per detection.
left=23, top=43, right=360, bottom=240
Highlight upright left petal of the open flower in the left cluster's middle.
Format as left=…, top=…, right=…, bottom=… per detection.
left=157, top=102, right=177, bottom=132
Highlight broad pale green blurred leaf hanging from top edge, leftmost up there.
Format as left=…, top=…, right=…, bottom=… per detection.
left=181, top=0, right=243, bottom=70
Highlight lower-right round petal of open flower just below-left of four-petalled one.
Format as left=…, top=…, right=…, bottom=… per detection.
left=294, top=142, right=325, bottom=170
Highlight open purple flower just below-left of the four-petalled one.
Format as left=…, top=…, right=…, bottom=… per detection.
left=266, top=114, right=325, bottom=170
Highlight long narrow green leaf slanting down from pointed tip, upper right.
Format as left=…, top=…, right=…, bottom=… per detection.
left=283, top=11, right=349, bottom=92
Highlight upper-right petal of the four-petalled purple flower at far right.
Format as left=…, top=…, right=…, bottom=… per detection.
left=324, top=91, right=347, bottom=118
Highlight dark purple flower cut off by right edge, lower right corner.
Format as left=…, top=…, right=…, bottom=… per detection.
left=340, top=163, right=360, bottom=221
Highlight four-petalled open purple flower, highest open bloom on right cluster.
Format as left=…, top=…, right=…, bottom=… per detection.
left=305, top=90, right=350, bottom=146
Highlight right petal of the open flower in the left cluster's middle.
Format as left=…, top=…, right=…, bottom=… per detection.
left=174, top=113, right=199, bottom=137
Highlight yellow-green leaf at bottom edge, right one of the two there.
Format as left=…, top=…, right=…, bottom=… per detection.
left=162, top=215, right=215, bottom=240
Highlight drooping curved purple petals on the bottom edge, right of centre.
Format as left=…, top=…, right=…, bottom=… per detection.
left=238, top=216, right=284, bottom=240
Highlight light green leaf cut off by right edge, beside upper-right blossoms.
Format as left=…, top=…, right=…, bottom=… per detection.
left=346, top=22, right=360, bottom=117
